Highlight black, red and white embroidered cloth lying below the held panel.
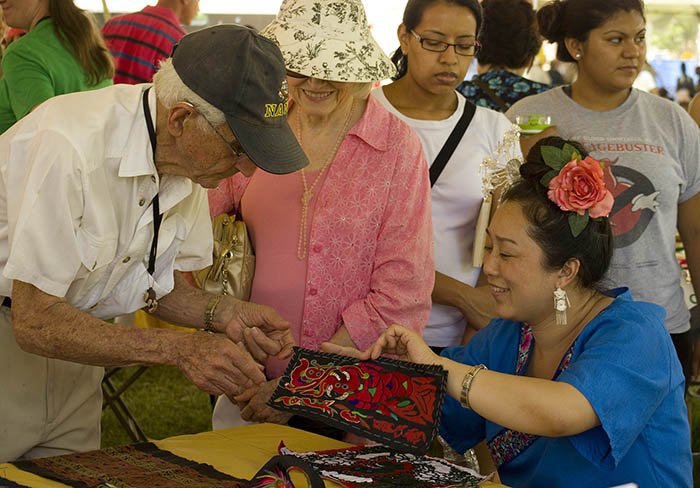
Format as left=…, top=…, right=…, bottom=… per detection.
left=279, top=442, right=485, bottom=488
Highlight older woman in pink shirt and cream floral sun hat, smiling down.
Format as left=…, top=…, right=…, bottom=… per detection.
left=210, top=0, right=434, bottom=428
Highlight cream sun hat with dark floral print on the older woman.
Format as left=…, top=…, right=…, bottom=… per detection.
left=260, top=0, right=396, bottom=83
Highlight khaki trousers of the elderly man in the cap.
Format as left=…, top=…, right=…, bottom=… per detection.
left=0, top=307, right=104, bottom=462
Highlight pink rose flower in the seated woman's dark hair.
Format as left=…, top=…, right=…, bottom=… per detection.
left=547, top=156, right=614, bottom=219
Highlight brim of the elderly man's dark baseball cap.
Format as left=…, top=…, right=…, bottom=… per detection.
left=226, top=115, right=309, bottom=175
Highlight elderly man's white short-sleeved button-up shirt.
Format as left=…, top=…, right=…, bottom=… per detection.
left=0, top=85, right=212, bottom=318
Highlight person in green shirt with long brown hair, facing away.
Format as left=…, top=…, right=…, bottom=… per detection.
left=0, top=0, right=114, bottom=133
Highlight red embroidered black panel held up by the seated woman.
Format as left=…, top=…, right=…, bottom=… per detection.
left=268, top=347, right=447, bottom=454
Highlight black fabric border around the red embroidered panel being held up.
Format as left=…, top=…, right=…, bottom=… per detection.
left=267, top=346, right=447, bottom=455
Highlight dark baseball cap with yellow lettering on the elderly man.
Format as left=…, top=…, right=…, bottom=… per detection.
left=172, top=24, right=309, bottom=174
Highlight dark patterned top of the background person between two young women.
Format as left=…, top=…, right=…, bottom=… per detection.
left=457, top=70, right=552, bottom=112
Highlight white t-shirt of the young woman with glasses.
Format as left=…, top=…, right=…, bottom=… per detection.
left=372, top=88, right=512, bottom=347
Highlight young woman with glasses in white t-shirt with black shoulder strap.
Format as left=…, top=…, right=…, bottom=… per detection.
left=373, top=0, right=511, bottom=348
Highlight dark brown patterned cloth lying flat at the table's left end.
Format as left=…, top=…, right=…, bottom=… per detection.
left=10, top=442, right=247, bottom=488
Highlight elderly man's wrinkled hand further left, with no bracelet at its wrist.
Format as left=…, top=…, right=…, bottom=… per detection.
left=176, top=332, right=265, bottom=395
